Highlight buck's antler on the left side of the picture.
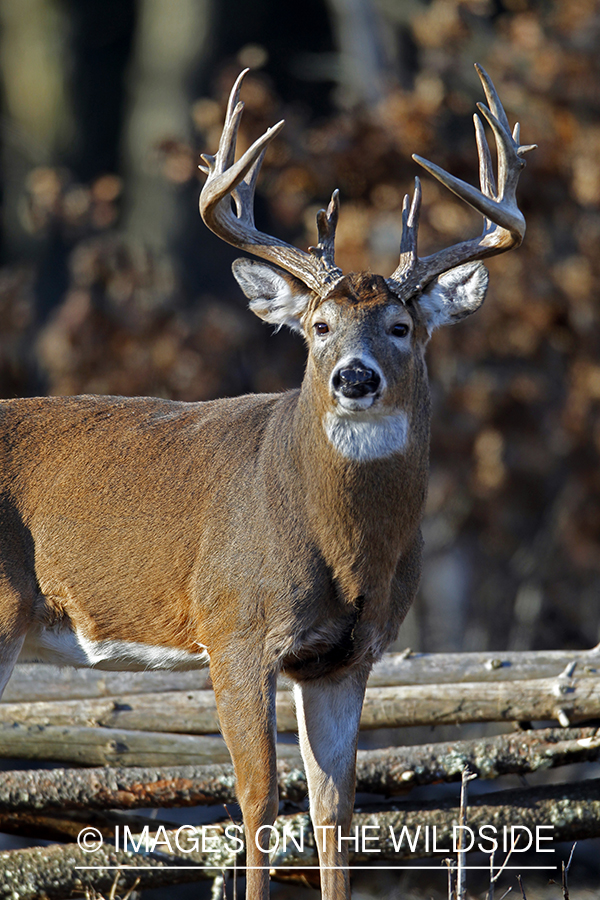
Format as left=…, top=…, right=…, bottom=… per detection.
left=200, top=69, right=342, bottom=295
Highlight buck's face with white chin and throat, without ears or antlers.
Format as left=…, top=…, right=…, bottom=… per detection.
left=303, top=274, right=425, bottom=462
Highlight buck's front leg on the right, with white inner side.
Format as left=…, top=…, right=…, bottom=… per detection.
left=294, top=671, right=368, bottom=900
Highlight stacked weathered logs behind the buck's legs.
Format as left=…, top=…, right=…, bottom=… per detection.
left=0, top=648, right=600, bottom=900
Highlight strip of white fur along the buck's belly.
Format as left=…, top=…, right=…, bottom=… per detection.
left=18, top=625, right=210, bottom=672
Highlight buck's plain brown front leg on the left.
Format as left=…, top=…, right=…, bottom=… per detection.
left=210, top=650, right=279, bottom=900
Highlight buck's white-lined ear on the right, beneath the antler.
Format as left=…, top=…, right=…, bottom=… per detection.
left=418, top=262, right=489, bottom=334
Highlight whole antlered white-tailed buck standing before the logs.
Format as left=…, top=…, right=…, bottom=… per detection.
left=0, top=66, right=534, bottom=900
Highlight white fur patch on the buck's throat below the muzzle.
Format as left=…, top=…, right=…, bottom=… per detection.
left=323, top=410, right=410, bottom=462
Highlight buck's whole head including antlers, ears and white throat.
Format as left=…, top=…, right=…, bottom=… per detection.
left=200, top=66, right=532, bottom=459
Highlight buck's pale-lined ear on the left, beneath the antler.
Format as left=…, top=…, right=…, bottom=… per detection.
left=232, top=259, right=311, bottom=334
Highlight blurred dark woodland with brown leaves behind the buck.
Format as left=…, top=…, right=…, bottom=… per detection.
left=0, top=0, right=600, bottom=650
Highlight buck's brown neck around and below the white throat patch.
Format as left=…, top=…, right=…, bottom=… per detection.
left=289, top=373, right=429, bottom=600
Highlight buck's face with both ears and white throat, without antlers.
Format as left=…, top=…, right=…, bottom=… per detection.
left=233, top=260, right=487, bottom=461
